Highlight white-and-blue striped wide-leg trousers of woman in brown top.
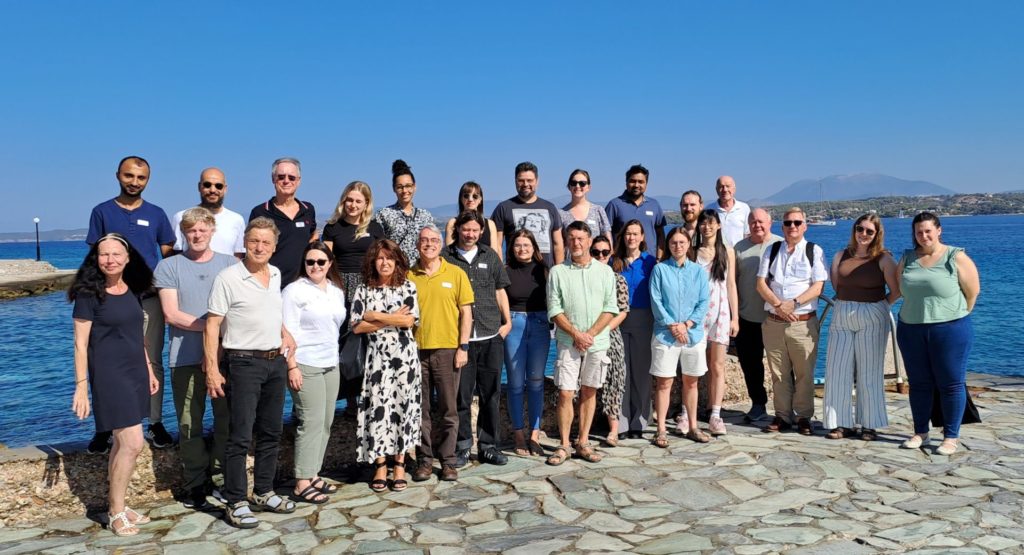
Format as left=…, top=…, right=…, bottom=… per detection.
left=822, top=300, right=890, bottom=430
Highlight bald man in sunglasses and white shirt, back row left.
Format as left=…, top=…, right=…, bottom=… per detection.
left=171, top=168, right=246, bottom=258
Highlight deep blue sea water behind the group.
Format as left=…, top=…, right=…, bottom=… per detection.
left=0, top=212, right=1024, bottom=446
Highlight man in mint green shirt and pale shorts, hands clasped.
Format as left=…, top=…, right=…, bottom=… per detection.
left=548, top=221, right=618, bottom=466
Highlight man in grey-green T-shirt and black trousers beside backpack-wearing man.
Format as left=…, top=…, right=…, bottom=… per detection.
left=734, top=208, right=782, bottom=422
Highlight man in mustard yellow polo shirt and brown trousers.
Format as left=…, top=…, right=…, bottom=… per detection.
left=409, top=225, right=473, bottom=481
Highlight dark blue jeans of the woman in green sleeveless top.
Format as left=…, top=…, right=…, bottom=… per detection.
left=896, top=315, right=974, bottom=438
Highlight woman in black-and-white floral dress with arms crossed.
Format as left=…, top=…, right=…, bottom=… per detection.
left=351, top=239, right=422, bottom=492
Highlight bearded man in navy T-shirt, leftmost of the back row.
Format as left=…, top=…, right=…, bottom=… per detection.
left=85, top=156, right=174, bottom=454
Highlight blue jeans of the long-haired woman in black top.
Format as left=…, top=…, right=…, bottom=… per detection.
left=505, top=312, right=551, bottom=430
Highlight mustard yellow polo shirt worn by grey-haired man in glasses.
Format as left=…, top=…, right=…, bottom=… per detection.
left=409, top=258, right=473, bottom=349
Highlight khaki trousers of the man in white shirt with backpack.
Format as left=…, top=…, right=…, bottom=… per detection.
left=761, top=315, right=818, bottom=424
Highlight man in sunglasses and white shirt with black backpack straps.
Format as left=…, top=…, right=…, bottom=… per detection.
left=757, top=207, right=828, bottom=435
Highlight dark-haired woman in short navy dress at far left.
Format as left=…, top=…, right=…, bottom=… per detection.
left=68, top=233, right=159, bottom=536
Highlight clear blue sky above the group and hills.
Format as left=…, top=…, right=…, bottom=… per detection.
left=0, top=1, right=1024, bottom=231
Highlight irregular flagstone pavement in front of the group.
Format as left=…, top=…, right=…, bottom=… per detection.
left=0, top=376, right=1024, bottom=555
